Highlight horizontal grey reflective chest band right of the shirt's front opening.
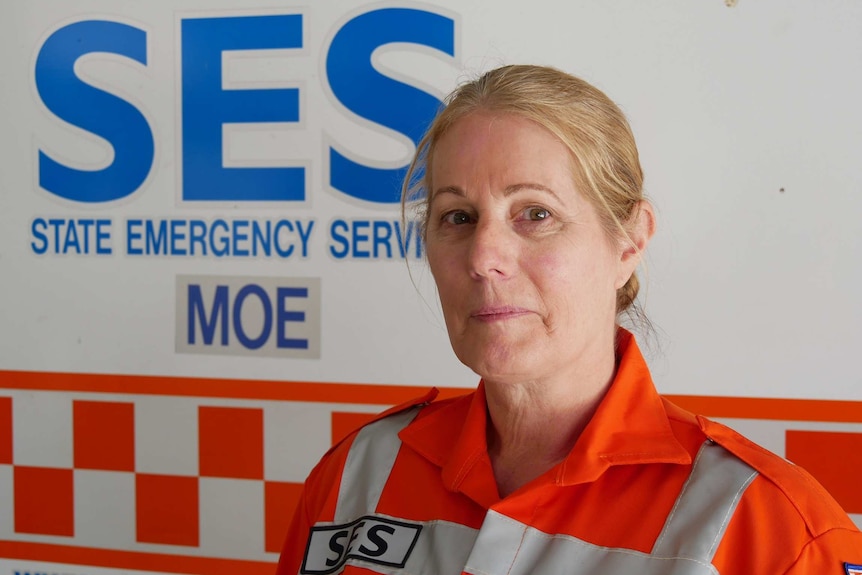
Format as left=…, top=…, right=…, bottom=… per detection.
left=464, top=511, right=718, bottom=575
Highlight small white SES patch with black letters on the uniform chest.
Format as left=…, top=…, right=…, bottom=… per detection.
left=299, top=515, right=422, bottom=575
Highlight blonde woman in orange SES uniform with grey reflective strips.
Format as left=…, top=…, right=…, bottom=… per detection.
left=278, top=66, right=862, bottom=575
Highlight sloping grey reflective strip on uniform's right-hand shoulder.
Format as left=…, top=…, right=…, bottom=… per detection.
left=652, top=441, right=757, bottom=562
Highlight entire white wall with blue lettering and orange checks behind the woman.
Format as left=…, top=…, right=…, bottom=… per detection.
left=0, top=0, right=862, bottom=574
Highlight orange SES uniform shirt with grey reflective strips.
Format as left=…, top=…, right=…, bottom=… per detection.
left=278, top=332, right=862, bottom=575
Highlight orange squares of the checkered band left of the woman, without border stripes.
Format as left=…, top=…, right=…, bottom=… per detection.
left=0, top=397, right=392, bottom=553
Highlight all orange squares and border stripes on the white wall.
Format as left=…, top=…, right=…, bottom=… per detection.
left=0, top=371, right=862, bottom=575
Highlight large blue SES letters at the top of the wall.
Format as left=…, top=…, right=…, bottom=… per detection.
left=34, top=7, right=456, bottom=204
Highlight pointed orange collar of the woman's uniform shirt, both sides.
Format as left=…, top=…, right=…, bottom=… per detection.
left=400, top=328, right=691, bottom=499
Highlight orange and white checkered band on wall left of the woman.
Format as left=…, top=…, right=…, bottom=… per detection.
left=0, top=390, right=383, bottom=561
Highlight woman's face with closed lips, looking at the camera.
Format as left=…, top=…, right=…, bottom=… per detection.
left=426, top=112, right=637, bottom=381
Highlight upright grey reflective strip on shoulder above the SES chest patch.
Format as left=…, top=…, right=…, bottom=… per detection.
left=335, top=407, right=419, bottom=523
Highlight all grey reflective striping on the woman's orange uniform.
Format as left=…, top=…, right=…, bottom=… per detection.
left=326, top=414, right=757, bottom=575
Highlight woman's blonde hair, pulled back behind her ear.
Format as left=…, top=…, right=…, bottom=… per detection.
left=402, top=65, right=644, bottom=315
